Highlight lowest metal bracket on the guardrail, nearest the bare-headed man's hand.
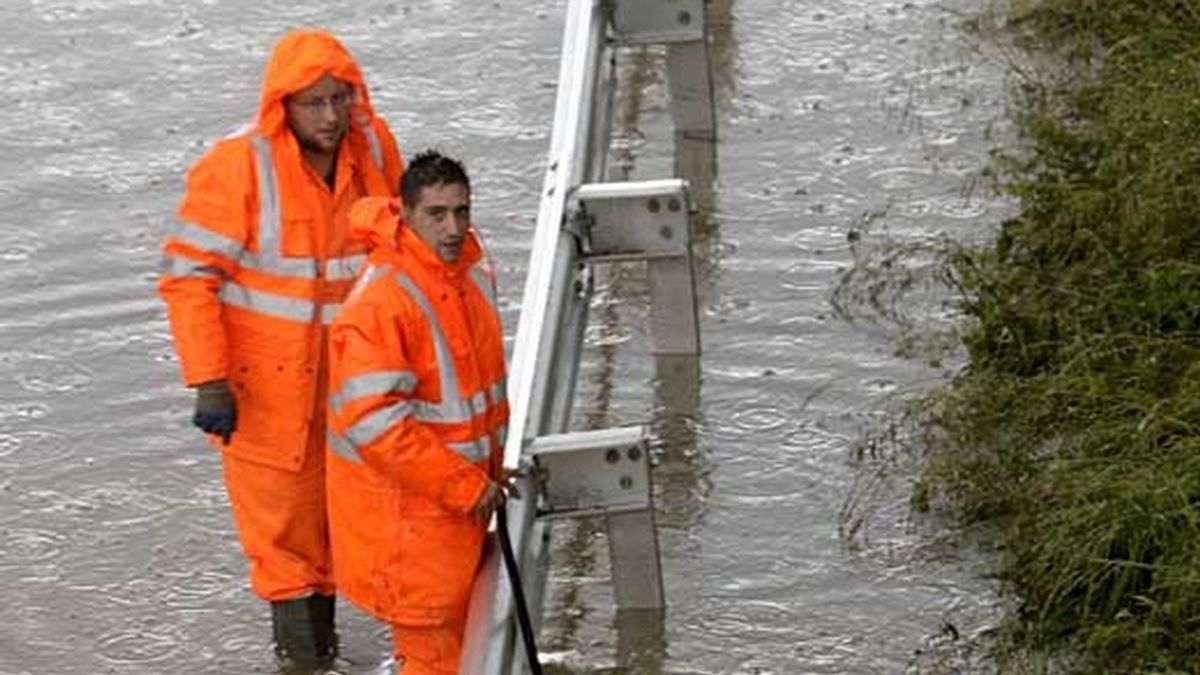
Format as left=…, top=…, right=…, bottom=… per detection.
left=529, top=426, right=650, bottom=518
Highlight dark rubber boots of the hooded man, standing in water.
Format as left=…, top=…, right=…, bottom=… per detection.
left=271, top=595, right=337, bottom=674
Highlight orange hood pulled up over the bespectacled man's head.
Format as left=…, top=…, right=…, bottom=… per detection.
left=258, top=30, right=374, bottom=137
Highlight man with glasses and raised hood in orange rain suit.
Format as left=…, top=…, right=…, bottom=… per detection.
left=158, top=30, right=403, bottom=667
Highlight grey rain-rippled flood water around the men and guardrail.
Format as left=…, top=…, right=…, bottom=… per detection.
left=0, top=0, right=1007, bottom=675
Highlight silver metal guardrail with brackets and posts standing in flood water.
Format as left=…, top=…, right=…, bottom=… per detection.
left=460, top=0, right=715, bottom=675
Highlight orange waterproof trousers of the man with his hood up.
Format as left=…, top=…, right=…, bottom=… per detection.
left=222, top=418, right=334, bottom=602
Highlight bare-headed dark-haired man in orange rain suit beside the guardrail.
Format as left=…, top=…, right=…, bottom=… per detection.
left=328, top=153, right=509, bottom=675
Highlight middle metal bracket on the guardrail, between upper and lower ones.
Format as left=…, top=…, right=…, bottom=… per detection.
left=575, top=178, right=691, bottom=257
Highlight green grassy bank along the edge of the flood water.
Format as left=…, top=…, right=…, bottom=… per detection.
left=883, top=0, right=1200, bottom=673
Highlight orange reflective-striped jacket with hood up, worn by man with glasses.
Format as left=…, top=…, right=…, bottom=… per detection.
left=158, top=30, right=403, bottom=470
